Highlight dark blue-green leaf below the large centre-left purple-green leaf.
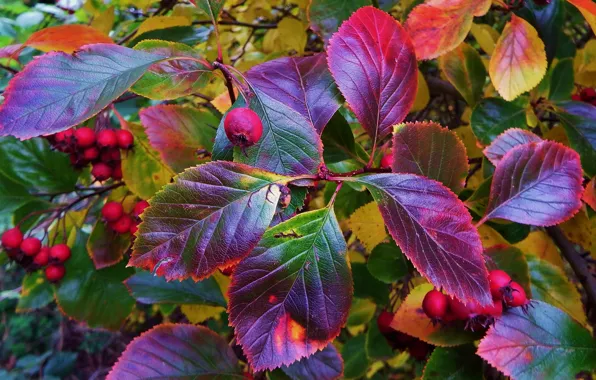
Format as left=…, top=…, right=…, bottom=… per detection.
left=124, top=272, right=227, bottom=307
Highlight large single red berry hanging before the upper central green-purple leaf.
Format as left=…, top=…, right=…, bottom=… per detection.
left=224, top=108, right=263, bottom=148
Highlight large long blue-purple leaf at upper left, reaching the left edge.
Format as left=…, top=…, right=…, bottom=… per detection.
left=0, top=44, right=164, bottom=139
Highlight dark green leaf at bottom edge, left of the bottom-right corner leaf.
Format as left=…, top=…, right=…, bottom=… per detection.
left=422, top=344, right=483, bottom=380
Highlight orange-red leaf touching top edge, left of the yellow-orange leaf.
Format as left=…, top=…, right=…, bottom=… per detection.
left=405, top=0, right=491, bottom=60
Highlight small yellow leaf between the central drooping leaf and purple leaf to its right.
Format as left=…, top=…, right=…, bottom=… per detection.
left=348, top=202, right=387, bottom=252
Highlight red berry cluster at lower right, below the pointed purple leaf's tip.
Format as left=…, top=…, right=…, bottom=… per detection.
left=422, top=270, right=528, bottom=329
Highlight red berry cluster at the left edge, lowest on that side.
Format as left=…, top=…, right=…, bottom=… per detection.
left=2, top=227, right=70, bottom=282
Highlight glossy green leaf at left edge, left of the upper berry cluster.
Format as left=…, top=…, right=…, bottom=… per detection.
left=0, top=137, right=79, bottom=193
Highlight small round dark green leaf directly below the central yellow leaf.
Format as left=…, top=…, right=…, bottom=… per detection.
left=366, top=242, right=411, bottom=284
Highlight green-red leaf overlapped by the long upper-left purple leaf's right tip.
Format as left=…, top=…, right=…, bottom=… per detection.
left=131, top=40, right=213, bottom=100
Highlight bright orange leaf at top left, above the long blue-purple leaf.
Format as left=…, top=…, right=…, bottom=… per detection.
left=23, top=24, right=114, bottom=54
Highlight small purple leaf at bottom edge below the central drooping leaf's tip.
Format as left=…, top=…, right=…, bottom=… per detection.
left=281, top=343, right=344, bottom=380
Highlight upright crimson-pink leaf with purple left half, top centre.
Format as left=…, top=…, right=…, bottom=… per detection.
left=327, top=6, right=418, bottom=143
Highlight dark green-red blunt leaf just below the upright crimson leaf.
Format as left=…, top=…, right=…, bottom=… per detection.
left=391, top=122, right=468, bottom=193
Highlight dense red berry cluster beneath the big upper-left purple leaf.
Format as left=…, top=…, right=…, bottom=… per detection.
left=48, top=127, right=134, bottom=181
